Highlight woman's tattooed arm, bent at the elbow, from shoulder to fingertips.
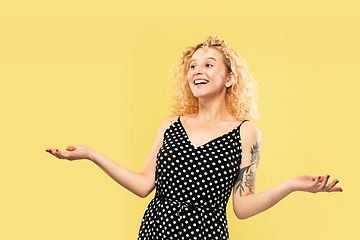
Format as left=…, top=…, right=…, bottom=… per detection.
left=233, top=122, right=342, bottom=219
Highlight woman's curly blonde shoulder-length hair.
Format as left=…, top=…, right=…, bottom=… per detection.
left=172, top=35, right=259, bottom=121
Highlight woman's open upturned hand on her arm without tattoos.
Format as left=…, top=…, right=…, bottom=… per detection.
left=45, top=145, right=94, bottom=160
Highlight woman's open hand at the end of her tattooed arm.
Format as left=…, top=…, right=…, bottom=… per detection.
left=289, top=175, right=343, bottom=193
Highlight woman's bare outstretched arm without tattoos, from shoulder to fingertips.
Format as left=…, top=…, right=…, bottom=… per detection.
left=46, top=116, right=176, bottom=197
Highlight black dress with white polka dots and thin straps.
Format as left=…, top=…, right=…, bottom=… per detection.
left=138, top=117, right=248, bottom=240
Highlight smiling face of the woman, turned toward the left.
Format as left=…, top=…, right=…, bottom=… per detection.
left=187, top=47, right=232, bottom=99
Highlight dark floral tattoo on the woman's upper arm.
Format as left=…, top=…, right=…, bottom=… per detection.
left=235, top=131, right=261, bottom=197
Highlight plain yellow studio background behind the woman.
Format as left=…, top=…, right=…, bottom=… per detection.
left=0, top=0, right=360, bottom=240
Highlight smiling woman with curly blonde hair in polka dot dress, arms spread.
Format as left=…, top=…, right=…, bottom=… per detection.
left=46, top=35, right=342, bottom=239
